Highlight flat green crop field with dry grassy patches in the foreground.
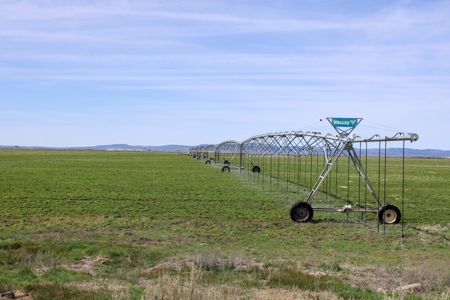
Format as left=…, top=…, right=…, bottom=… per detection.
left=0, top=149, right=450, bottom=299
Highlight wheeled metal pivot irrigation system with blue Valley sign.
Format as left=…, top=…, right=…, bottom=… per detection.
left=189, top=118, right=419, bottom=224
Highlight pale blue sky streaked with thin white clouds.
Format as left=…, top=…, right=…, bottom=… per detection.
left=0, top=0, right=450, bottom=150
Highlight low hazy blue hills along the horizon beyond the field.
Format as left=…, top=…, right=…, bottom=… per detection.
left=0, top=144, right=450, bottom=158
